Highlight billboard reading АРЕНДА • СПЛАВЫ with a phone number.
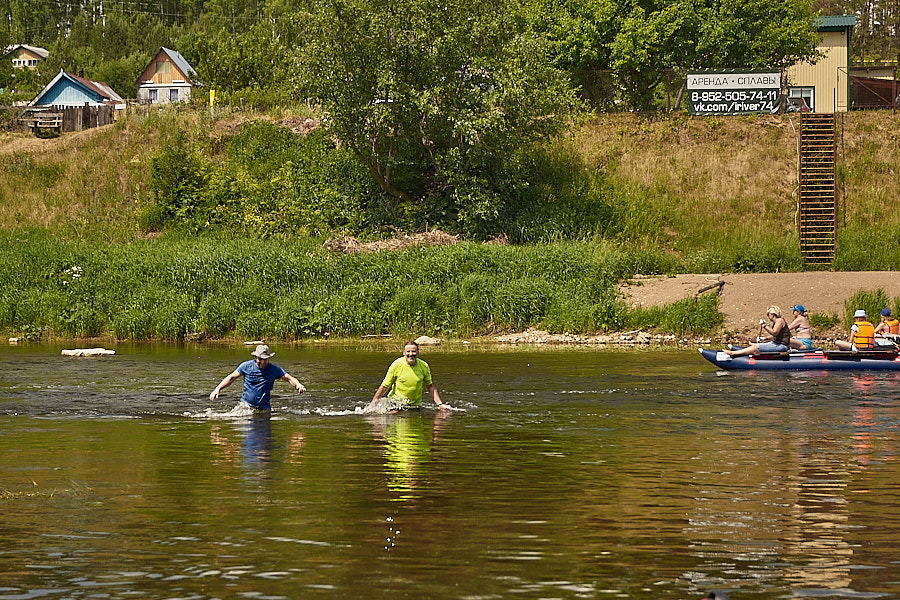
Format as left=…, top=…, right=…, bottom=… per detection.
left=687, top=71, right=781, bottom=115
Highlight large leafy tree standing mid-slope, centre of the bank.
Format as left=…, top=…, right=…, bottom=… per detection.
left=296, top=0, right=579, bottom=232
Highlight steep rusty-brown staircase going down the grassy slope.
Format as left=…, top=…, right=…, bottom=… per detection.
left=797, top=113, right=837, bottom=265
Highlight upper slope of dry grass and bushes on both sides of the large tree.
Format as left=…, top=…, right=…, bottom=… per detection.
left=0, top=108, right=900, bottom=262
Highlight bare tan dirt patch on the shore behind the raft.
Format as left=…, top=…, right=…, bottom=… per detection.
left=619, top=271, right=900, bottom=332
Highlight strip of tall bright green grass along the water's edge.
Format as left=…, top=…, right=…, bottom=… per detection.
left=0, top=230, right=717, bottom=340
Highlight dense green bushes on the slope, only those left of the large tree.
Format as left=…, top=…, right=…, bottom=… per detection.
left=146, top=121, right=378, bottom=234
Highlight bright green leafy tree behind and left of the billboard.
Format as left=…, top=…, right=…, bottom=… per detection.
left=523, top=0, right=818, bottom=110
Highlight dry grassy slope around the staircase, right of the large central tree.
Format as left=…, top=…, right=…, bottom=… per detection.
left=573, top=111, right=900, bottom=272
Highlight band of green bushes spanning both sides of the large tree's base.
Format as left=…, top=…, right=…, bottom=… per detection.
left=139, top=115, right=632, bottom=243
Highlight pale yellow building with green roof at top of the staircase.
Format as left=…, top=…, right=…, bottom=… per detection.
left=785, top=15, right=856, bottom=113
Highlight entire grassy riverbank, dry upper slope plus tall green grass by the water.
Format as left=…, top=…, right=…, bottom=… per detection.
left=0, top=109, right=900, bottom=340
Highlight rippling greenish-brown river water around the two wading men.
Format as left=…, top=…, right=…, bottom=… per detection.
left=0, top=343, right=900, bottom=600
